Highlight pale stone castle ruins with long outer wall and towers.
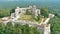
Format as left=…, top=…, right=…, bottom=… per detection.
left=2, top=5, right=54, bottom=34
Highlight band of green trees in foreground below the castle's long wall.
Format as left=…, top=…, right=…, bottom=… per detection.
left=0, top=22, right=40, bottom=34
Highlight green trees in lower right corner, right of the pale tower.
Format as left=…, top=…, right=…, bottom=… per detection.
left=49, top=16, right=60, bottom=34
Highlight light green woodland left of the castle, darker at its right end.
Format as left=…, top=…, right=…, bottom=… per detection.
left=0, top=8, right=15, bottom=18
